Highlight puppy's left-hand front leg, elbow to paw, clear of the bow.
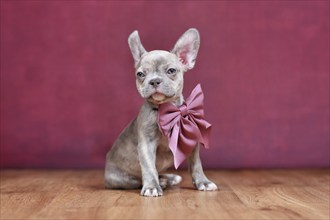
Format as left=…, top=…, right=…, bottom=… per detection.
left=138, top=138, right=163, bottom=197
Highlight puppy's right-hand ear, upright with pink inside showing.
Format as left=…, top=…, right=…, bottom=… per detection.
left=171, top=28, right=200, bottom=70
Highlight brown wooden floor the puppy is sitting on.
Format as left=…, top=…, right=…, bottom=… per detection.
left=0, top=169, right=330, bottom=219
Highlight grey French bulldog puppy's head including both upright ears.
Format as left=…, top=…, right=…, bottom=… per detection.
left=128, top=29, right=200, bottom=105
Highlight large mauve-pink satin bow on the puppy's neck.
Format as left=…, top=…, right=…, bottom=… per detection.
left=158, top=84, right=211, bottom=169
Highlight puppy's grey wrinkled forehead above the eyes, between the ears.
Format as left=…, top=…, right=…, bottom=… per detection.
left=137, top=50, right=181, bottom=71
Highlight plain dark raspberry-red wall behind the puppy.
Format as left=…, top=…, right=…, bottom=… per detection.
left=0, top=0, right=330, bottom=168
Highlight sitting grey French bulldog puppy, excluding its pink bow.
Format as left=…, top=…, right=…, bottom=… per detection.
left=104, top=28, right=217, bottom=197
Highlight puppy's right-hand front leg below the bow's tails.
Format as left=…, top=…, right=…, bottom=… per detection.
left=189, top=144, right=218, bottom=191
